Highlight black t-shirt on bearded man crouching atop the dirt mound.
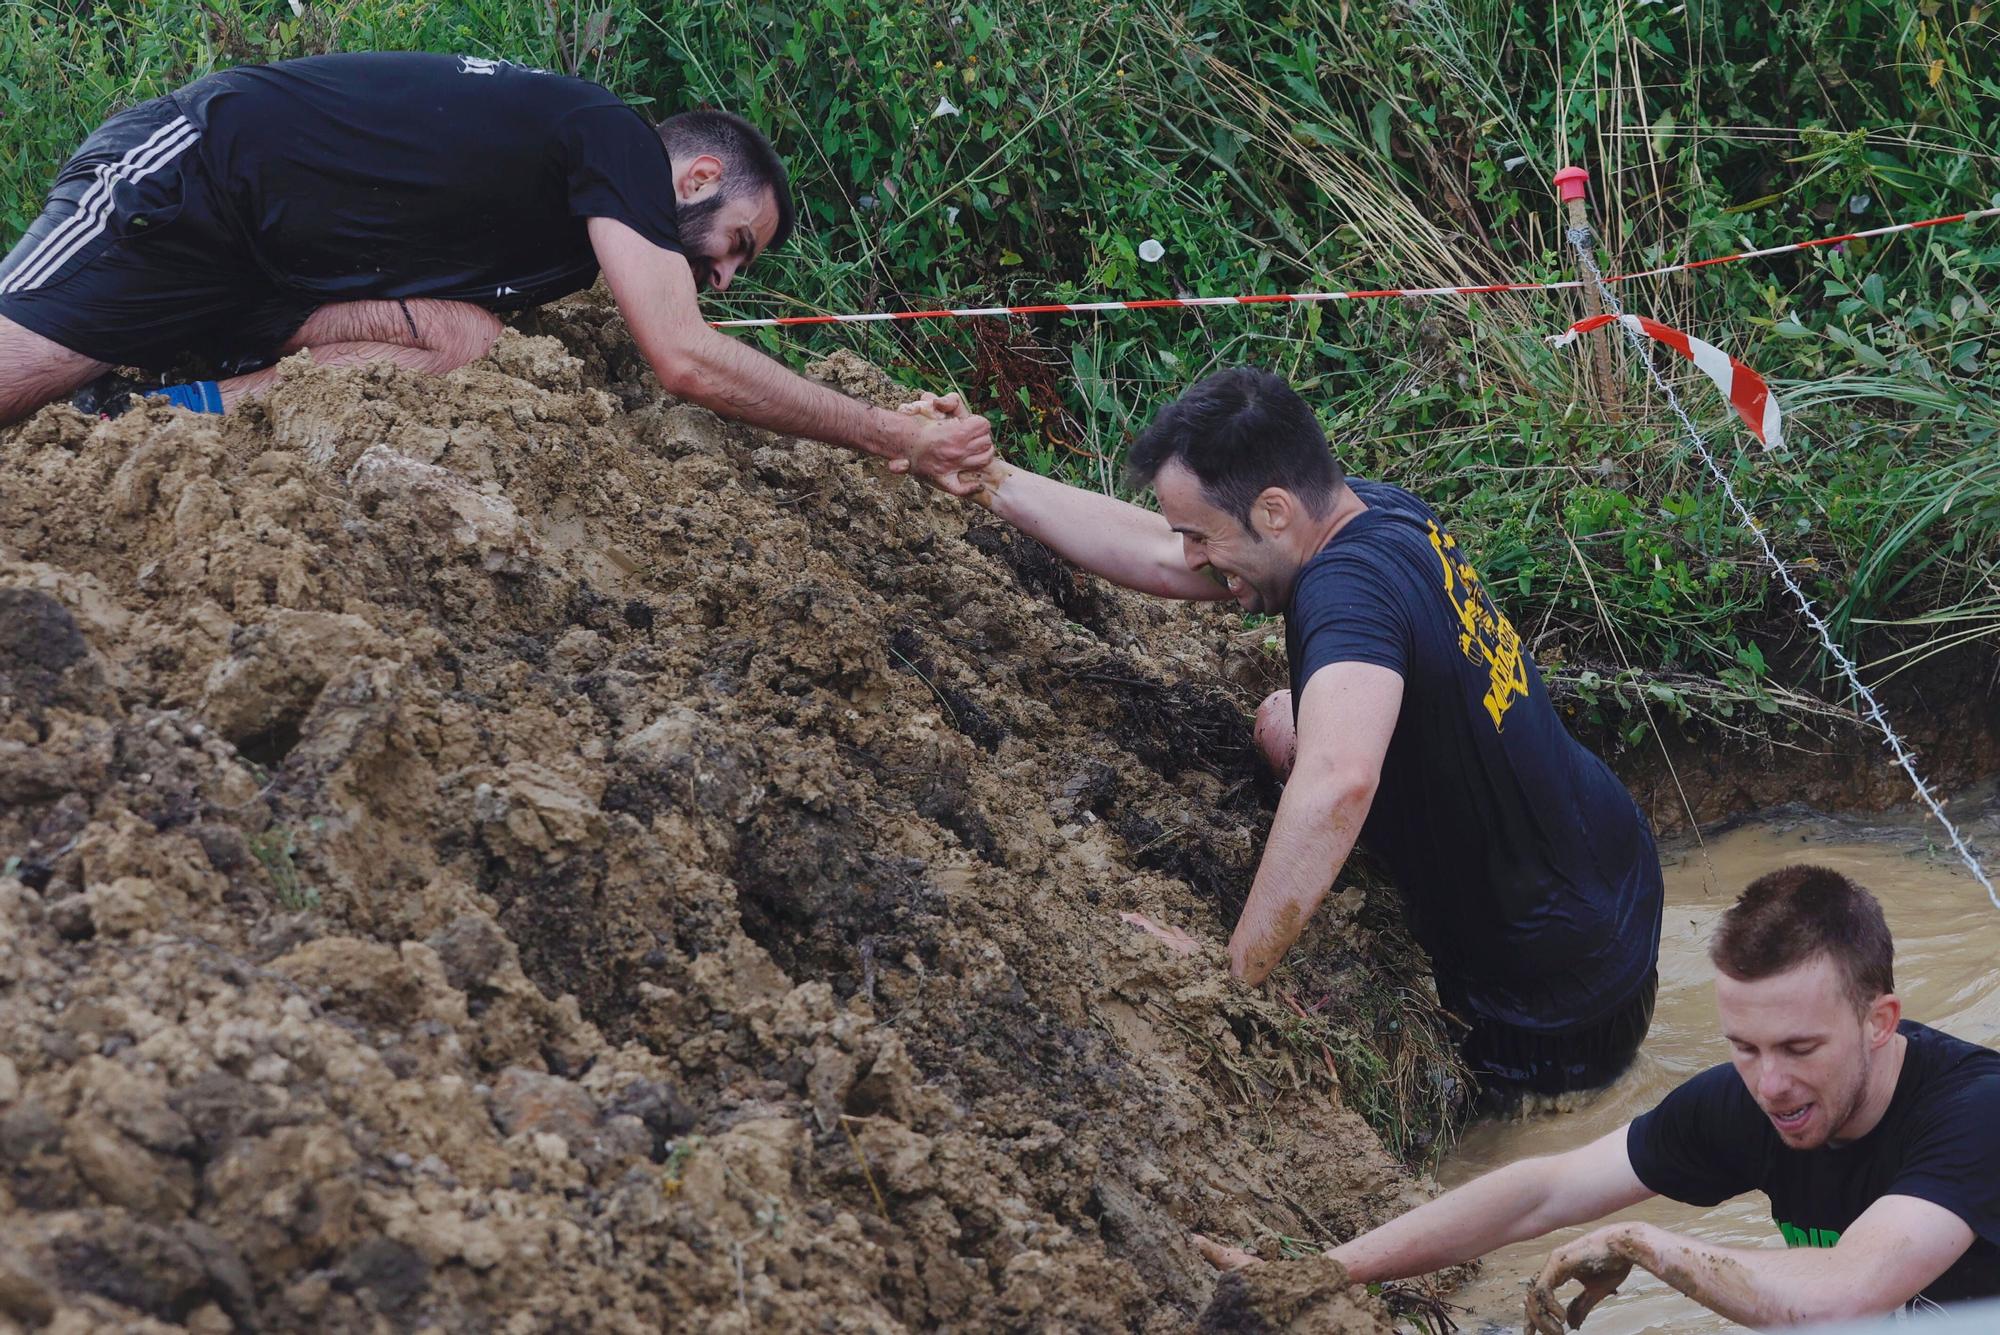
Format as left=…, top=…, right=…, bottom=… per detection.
left=174, top=52, right=682, bottom=310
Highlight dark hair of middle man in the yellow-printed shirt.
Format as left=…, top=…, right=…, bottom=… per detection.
left=1130, top=366, right=1346, bottom=528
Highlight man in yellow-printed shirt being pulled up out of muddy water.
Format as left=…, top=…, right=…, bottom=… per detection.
left=904, top=368, right=1664, bottom=1093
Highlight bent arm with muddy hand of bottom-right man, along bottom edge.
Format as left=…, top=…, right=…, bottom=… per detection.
left=1528, top=1195, right=1972, bottom=1335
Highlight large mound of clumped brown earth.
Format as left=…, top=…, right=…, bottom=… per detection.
left=0, top=298, right=1452, bottom=1331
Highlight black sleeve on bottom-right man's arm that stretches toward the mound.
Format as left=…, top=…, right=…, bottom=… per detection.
left=1626, top=1065, right=1764, bottom=1205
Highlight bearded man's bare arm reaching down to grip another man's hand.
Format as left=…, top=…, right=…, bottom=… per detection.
left=588, top=218, right=992, bottom=496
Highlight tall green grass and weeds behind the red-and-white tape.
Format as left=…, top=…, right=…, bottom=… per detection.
left=0, top=0, right=2000, bottom=725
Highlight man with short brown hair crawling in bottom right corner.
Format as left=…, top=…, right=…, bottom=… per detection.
left=1196, top=867, right=2000, bottom=1335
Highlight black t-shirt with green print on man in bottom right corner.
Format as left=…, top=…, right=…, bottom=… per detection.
left=1626, top=1019, right=2000, bottom=1303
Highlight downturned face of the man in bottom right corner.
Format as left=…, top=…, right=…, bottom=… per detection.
left=1716, top=955, right=1902, bottom=1149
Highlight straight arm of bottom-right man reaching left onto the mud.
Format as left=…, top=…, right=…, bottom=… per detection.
left=1196, top=1127, right=1652, bottom=1283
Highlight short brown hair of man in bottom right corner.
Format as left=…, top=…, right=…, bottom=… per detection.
left=1708, top=863, right=1896, bottom=1009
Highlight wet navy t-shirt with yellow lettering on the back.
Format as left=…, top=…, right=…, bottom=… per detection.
left=1284, top=480, right=1664, bottom=1033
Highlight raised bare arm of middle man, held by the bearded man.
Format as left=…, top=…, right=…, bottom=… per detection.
left=972, top=460, right=1228, bottom=600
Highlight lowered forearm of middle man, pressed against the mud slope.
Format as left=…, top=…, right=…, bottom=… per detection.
left=1230, top=775, right=1374, bottom=983
